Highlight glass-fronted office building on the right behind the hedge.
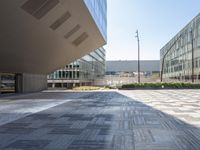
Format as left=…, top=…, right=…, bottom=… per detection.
left=160, top=14, right=200, bottom=81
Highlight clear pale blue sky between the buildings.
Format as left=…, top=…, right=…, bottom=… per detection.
left=105, top=0, right=200, bottom=60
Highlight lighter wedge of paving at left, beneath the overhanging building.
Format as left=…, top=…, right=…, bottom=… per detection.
left=0, top=92, right=89, bottom=125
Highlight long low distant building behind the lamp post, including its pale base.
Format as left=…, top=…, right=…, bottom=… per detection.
left=95, top=60, right=160, bottom=86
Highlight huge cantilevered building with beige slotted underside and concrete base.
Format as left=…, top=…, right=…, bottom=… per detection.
left=0, top=0, right=107, bottom=92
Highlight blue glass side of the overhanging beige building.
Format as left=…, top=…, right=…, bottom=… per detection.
left=84, top=0, right=107, bottom=40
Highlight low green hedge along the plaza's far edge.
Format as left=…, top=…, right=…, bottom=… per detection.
left=121, top=82, right=200, bottom=89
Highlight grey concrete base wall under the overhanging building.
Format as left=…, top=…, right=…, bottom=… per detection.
left=22, top=73, right=47, bottom=93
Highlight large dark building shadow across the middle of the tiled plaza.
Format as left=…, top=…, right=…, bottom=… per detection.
left=0, top=92, right=200, bottom=150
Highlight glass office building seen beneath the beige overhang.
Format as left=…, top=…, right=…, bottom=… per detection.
left=48, top=48, right=105, bottom=88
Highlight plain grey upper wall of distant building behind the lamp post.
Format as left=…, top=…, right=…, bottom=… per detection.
left=106, top=60, right=160, bottom=74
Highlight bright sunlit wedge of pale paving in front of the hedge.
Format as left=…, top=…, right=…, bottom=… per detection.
left=121, top=90, right=200, bottom=127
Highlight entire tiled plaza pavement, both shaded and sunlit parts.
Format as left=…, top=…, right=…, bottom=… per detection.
left=0, top=90, right=200, bottom=150
